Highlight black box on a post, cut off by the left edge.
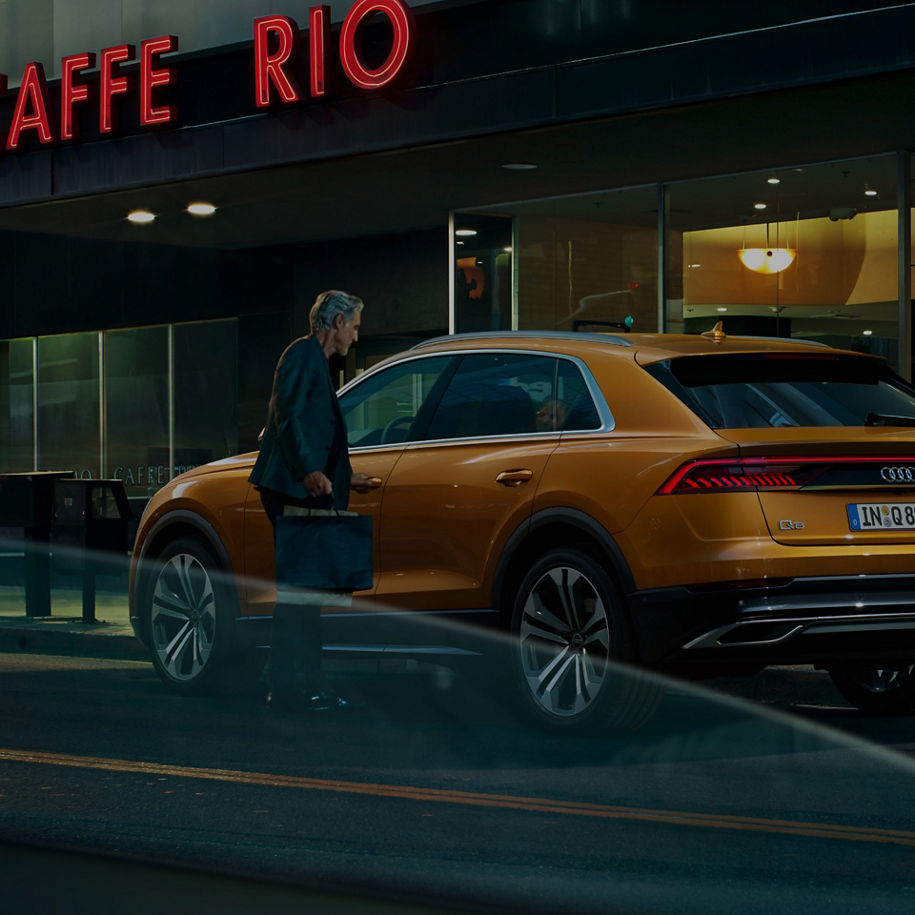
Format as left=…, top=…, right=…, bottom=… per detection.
left=0, top=470, right=75, bottom=616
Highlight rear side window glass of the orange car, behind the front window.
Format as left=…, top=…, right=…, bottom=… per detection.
left=423, top=353, right=600, bottom=439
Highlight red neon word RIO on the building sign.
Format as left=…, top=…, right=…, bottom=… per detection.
left=254, top=0, right=415, bottom=108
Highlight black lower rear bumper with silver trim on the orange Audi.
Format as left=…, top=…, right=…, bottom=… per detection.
left=629, top=575, right=915, bottom=667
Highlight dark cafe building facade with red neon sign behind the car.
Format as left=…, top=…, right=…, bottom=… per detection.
left=0, top=0, right=915, bottom=516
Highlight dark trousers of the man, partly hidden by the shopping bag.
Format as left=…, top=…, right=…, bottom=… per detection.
left=259, top=489, right=324, bottom=696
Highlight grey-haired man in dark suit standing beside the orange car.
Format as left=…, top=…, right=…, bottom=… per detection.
left=249, top=290, right=368, bottom=710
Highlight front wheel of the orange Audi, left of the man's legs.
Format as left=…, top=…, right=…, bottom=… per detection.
left=141, top=537, right=263, bottom=694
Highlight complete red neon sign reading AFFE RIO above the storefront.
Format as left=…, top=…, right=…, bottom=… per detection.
left=0, top=0, right=416, bottom=151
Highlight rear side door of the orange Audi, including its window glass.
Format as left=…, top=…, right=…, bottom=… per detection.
left=376, top=352, right=559, bottom=611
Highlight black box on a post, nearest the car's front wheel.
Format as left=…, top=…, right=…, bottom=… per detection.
left=51, top=479, right=132, bottom=623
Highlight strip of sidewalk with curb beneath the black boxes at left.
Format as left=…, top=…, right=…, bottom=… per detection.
left=0, top=585, right=149, bottom=661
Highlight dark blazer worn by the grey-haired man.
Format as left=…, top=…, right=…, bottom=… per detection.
left=248, top=337, right=353, bottom=509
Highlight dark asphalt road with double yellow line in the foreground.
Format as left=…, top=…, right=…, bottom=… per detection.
left=0, top=654, right=915, bottom=915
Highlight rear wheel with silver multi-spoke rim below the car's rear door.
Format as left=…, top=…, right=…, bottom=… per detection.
left=511, top=549, right=665, bottom=734
